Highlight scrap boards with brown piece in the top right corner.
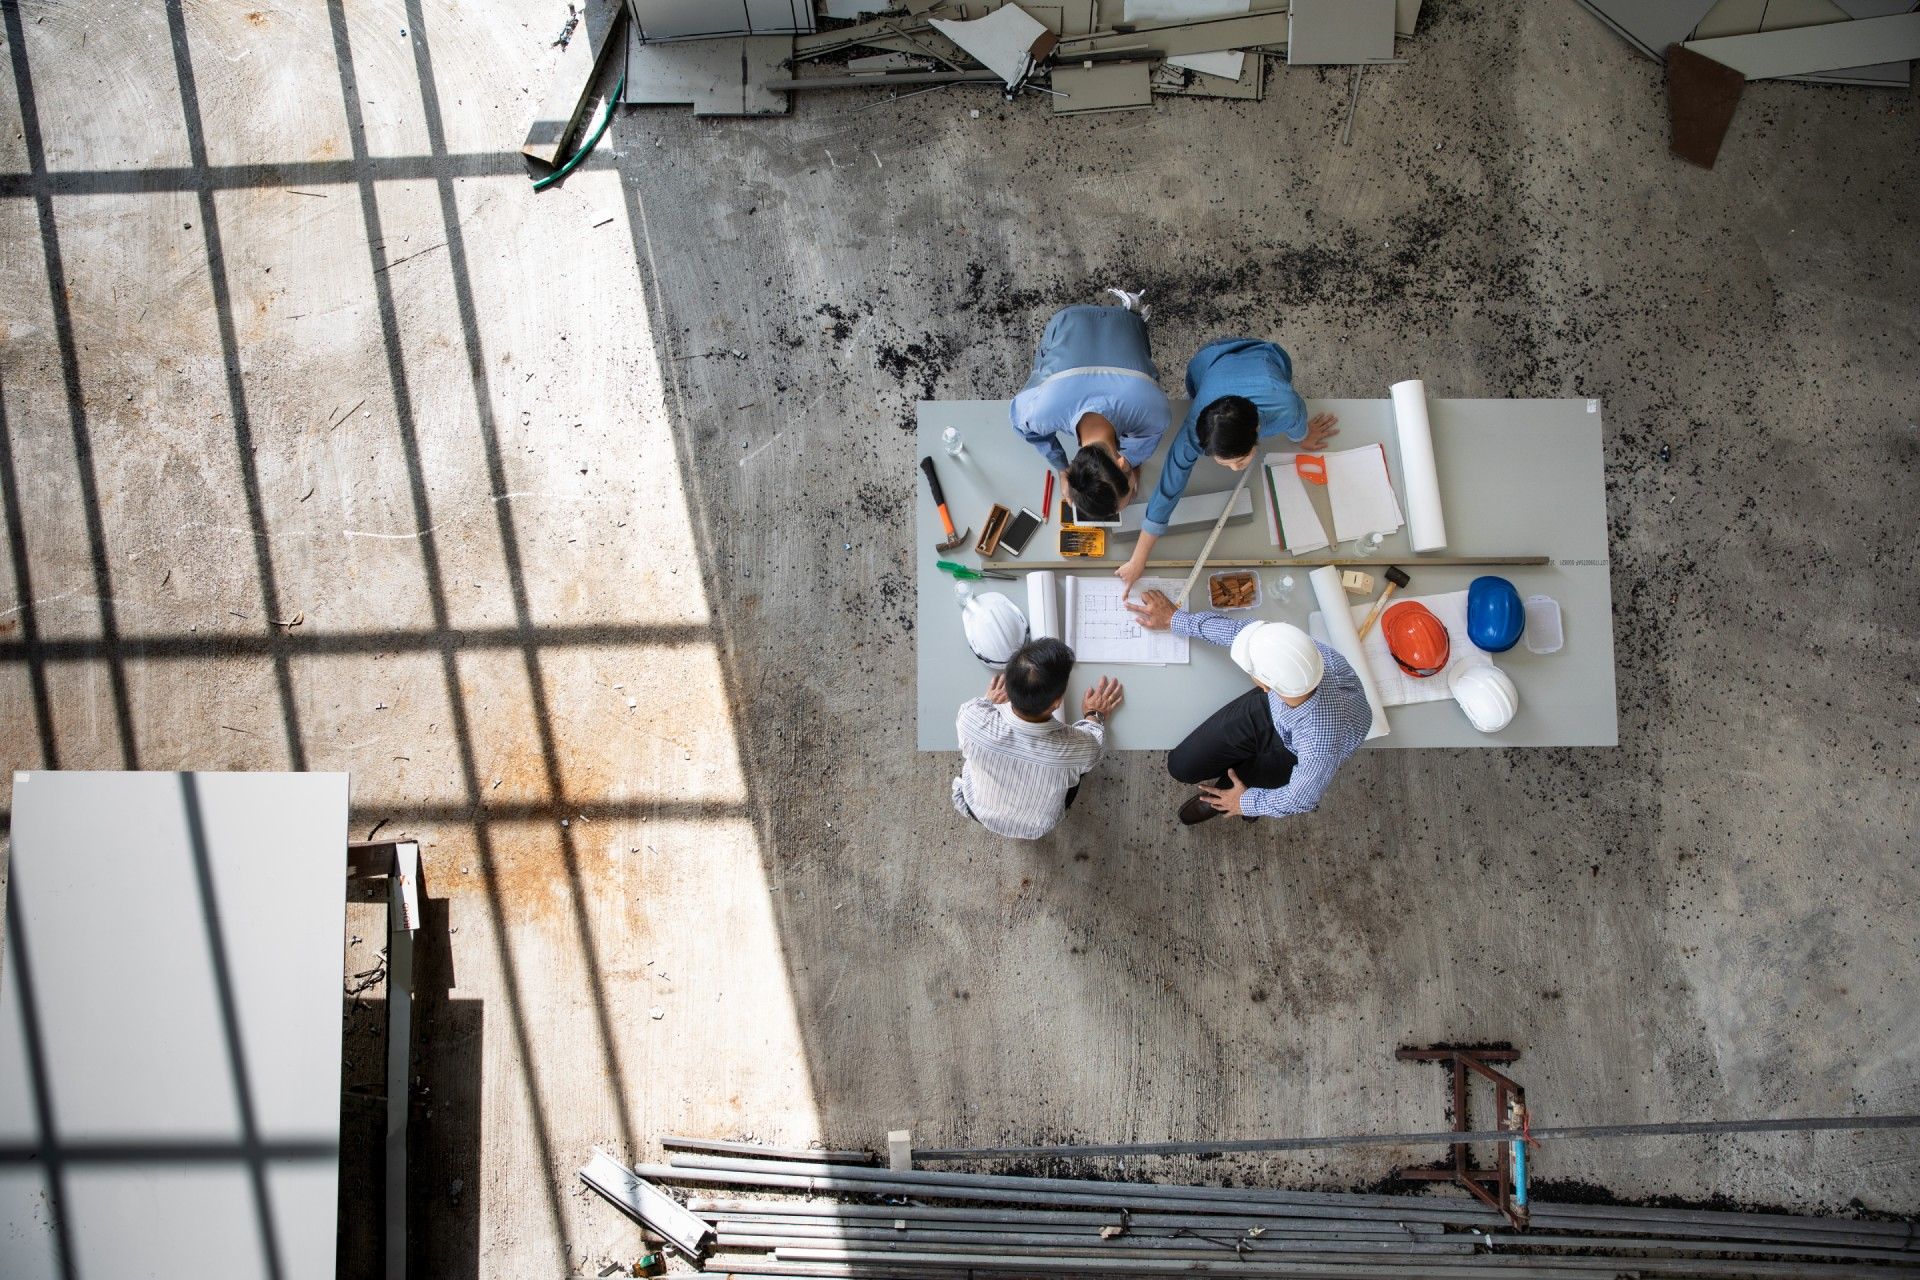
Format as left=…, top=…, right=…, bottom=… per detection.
left=1574, top=0, right=1920, bottom=169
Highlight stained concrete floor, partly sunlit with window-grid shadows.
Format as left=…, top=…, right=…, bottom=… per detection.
left=0, top=0, right=1920, bottom=1276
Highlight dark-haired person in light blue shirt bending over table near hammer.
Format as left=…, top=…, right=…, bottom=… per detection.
left=1010, top=290, right=1173, bottom=520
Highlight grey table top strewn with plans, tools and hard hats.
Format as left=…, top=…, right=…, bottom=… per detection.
left=914, top=399, right=1619, bottom=750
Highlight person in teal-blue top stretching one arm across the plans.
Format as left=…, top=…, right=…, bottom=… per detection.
left=1114, top=338, right=1338, bottom=587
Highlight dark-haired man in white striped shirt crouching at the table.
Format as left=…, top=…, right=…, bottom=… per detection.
left=952, top=639, right=1121, bottom=841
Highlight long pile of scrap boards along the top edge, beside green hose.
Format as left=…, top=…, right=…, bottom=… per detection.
left=520, top=0, right=1421, bottom=165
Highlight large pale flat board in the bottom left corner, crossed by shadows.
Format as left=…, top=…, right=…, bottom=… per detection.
left=0, top=771, right=348, bottom=1280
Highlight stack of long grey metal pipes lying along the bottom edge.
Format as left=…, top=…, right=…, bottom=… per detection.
left=602, top=1144, right=1920, bottom=1280
